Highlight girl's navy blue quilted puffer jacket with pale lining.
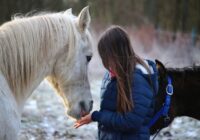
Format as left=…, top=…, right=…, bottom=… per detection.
left=92, top=60, right=158, bottom=140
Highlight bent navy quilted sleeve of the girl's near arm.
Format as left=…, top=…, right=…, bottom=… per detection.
left=92, top=74, right=153, bottom=132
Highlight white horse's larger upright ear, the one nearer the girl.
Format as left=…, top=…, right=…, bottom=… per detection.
left=78, top=6, right=91, bottom=32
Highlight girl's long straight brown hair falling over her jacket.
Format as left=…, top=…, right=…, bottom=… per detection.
left=98, top=26, right=147, bottom=113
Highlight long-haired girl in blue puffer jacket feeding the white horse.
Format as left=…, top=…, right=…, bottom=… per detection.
left=74, top=26, right=158, bottom=140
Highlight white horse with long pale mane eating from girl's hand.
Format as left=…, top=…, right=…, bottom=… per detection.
left=0, top=7, right=92, bottom=140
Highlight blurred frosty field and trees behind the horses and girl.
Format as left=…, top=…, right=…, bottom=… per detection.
left=0, top=0, right=200, bottom=140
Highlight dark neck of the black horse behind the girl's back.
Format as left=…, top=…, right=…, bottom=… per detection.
left=167, top=66, right=200, bottom=120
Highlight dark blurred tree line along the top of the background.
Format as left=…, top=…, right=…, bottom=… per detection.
left=0, top=0, right=200, bottom=34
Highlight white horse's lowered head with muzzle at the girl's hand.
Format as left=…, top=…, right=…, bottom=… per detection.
left=47, top=7, right=93, bottom=119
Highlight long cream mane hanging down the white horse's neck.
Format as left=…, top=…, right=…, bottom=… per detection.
left=0, top=12, right=76, bottom=94
